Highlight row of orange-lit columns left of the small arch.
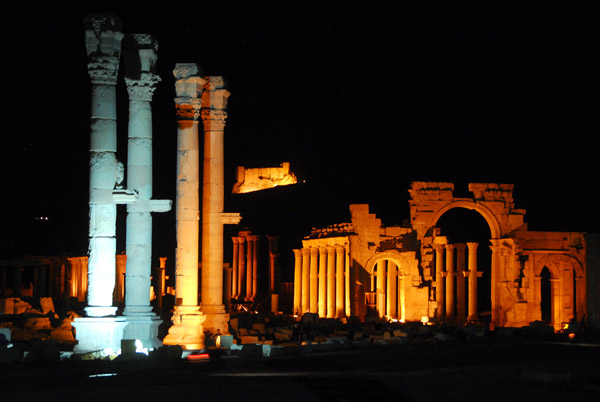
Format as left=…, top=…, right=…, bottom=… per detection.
left=293, top=245, right=350, bottom=318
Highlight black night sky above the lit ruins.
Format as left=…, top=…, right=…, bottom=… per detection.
left=0, top=1, right=600, bottom=274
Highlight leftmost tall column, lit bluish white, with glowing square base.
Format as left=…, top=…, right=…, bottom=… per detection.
left=73, top=14, right=128, bottom=353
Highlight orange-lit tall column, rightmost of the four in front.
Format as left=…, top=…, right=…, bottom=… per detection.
left=201, top=77, right=242, bottom=334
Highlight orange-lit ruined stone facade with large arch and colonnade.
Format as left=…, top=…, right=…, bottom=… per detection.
left=294, top=182, right=599, bottom=330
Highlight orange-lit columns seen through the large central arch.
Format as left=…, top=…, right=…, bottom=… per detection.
left=434, top=242, right=483, bottom=321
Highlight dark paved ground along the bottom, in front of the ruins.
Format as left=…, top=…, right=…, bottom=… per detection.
left=0, top=339, right=600, bottom=402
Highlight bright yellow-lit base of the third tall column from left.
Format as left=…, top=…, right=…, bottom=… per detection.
left=162, top=306, right=206, bottom=350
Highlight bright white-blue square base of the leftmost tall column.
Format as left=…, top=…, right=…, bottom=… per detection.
left=72, top=317, right=128, bottom=354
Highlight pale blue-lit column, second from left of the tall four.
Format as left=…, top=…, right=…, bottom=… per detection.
left=123, top=34, right=171, bottom=348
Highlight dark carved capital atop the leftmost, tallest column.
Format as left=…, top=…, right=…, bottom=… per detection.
left=84, top=14, right=123, bottom=85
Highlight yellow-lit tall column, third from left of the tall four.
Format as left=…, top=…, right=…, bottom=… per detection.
left=163, top=63, right=206, bottom=350
